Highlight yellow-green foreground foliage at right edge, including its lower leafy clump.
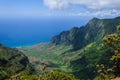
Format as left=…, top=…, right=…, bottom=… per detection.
left=97, top=25, right=120, bottom=80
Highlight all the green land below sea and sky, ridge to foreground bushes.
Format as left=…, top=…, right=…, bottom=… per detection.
left=0, top=17, right=120, bottom=80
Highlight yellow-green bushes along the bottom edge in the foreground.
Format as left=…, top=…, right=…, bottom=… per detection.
left=7, top=71, right=77, bottom=80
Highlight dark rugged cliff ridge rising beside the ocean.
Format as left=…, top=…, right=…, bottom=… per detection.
left=51, top=17, right=120, bottom=49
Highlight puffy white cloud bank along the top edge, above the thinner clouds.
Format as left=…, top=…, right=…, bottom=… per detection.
left=44, top=0, right=120, bottom=9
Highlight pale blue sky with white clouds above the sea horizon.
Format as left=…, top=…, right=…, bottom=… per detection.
left=0, top=0, right=120, bottom=18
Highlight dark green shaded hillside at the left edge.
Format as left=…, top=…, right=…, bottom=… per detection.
left=0, top=45, right=34, bottom=80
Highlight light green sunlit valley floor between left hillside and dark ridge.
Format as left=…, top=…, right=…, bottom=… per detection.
left=19, top=43, right=72, bottom=72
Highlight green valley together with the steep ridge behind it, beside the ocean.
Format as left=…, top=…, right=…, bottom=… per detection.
left=19, top=17, right=120, bottom=80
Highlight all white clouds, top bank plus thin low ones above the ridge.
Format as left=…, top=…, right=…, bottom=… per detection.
left=44, top=0, right=120, bottom=17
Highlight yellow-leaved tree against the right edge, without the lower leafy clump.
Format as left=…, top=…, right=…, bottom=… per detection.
left=103, top=25, right=120, bottom=77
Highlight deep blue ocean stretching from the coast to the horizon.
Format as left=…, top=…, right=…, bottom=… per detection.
left=0, top=17, right=89, bottom=48
